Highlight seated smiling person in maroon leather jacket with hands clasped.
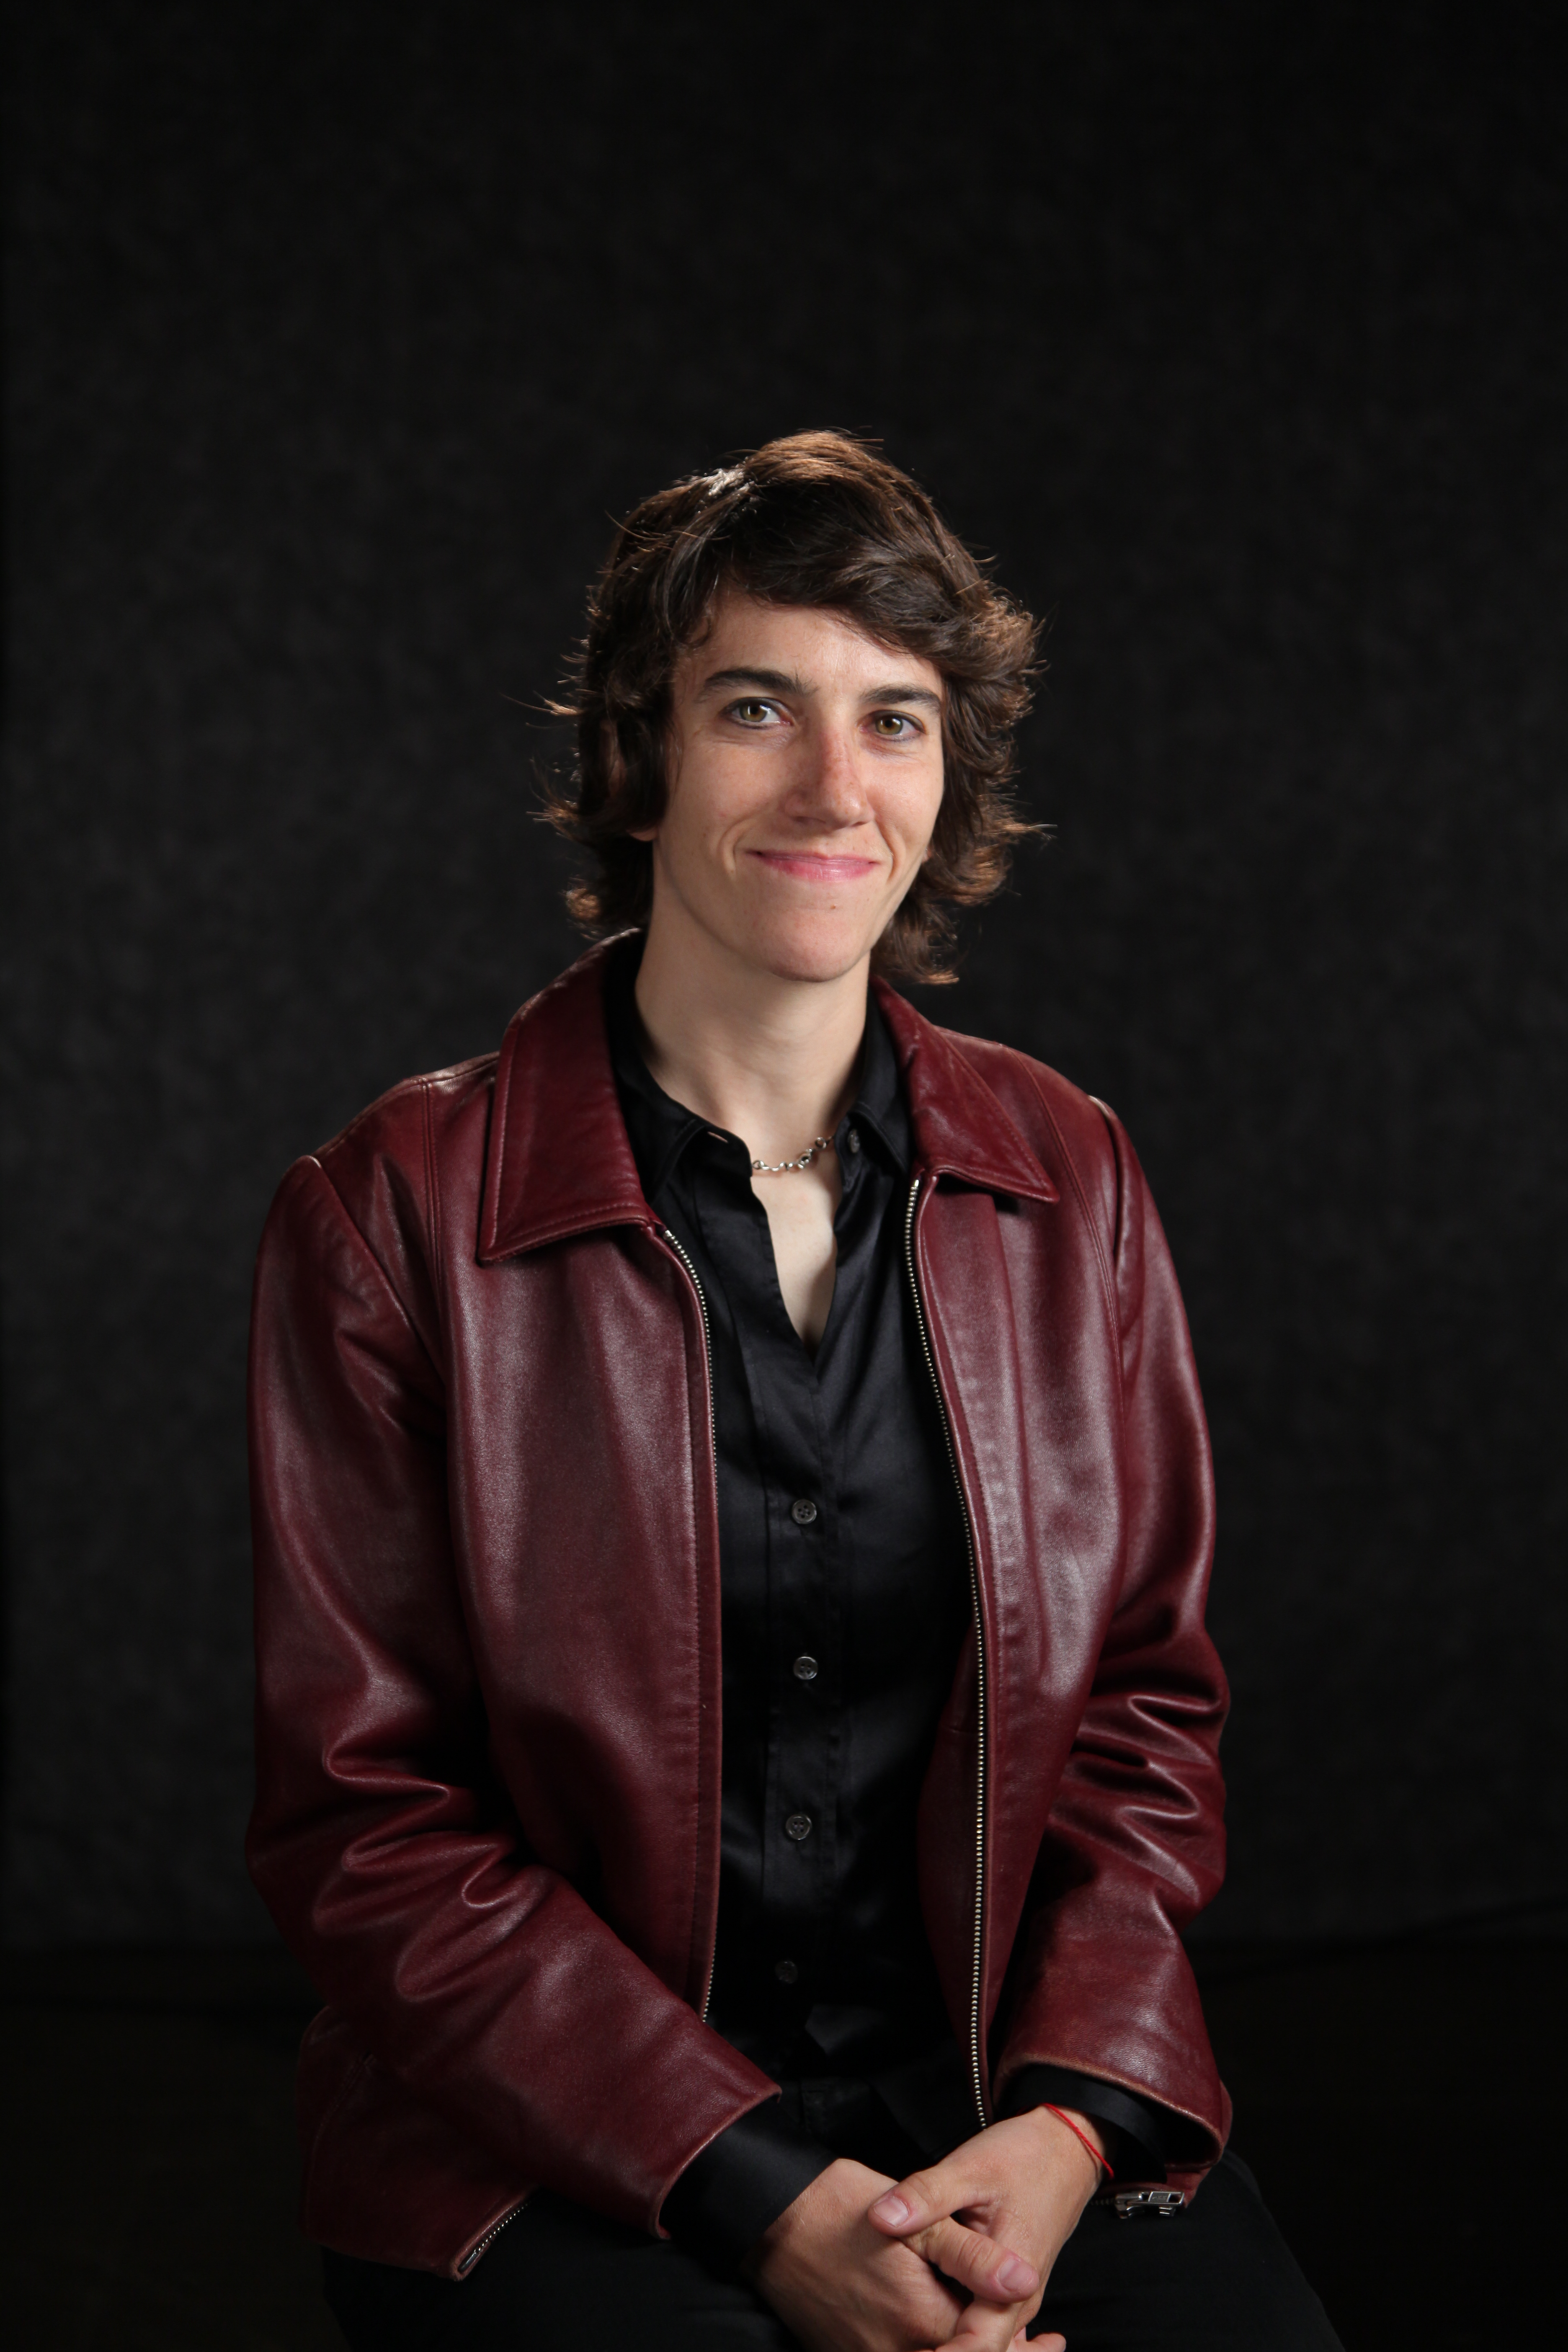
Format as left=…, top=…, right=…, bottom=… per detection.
left=249, top=433, right=1335, bottom=2352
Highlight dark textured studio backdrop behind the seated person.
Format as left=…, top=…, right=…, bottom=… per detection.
left=5, top=0, right=1568, bottom=1943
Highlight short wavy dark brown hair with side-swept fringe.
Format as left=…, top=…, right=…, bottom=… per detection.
left=545, top=433, right=1039, bottom=981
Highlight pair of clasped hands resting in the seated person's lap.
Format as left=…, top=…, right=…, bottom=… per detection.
left=748, top=2107, right=1100, bottom=2352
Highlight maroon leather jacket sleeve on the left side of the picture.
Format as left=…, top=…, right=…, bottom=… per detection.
left=247, top=1160, right=774, bottom=2227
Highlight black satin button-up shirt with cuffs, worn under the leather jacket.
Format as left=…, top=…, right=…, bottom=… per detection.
left=606, top=955, right=1171, bottom=2260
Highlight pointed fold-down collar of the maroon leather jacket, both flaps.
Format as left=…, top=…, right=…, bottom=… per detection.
left=480, top=941, right=1055, bottom=1265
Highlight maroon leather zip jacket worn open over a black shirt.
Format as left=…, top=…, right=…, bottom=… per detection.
left=249, top=950, right=1230, bottom=2277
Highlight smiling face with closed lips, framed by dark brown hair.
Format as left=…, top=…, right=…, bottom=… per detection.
left=640, top=593, right=943, bottom=981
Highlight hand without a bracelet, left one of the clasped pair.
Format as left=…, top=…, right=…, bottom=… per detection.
left=748, top=2133, right=1048, bottom=2352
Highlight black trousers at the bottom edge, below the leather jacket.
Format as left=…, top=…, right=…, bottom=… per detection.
left=325, top=2154, right=1340, bottom=2352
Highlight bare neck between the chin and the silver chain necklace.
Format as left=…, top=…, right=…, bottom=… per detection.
left=637, top=908, right=870, bottom=1162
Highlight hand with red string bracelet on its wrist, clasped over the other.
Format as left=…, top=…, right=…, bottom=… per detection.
left=867, top=2107, right=1103, bottom=2352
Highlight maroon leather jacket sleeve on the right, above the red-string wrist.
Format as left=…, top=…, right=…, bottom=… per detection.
left=997, top=1106, right=1230, bottom=2169
